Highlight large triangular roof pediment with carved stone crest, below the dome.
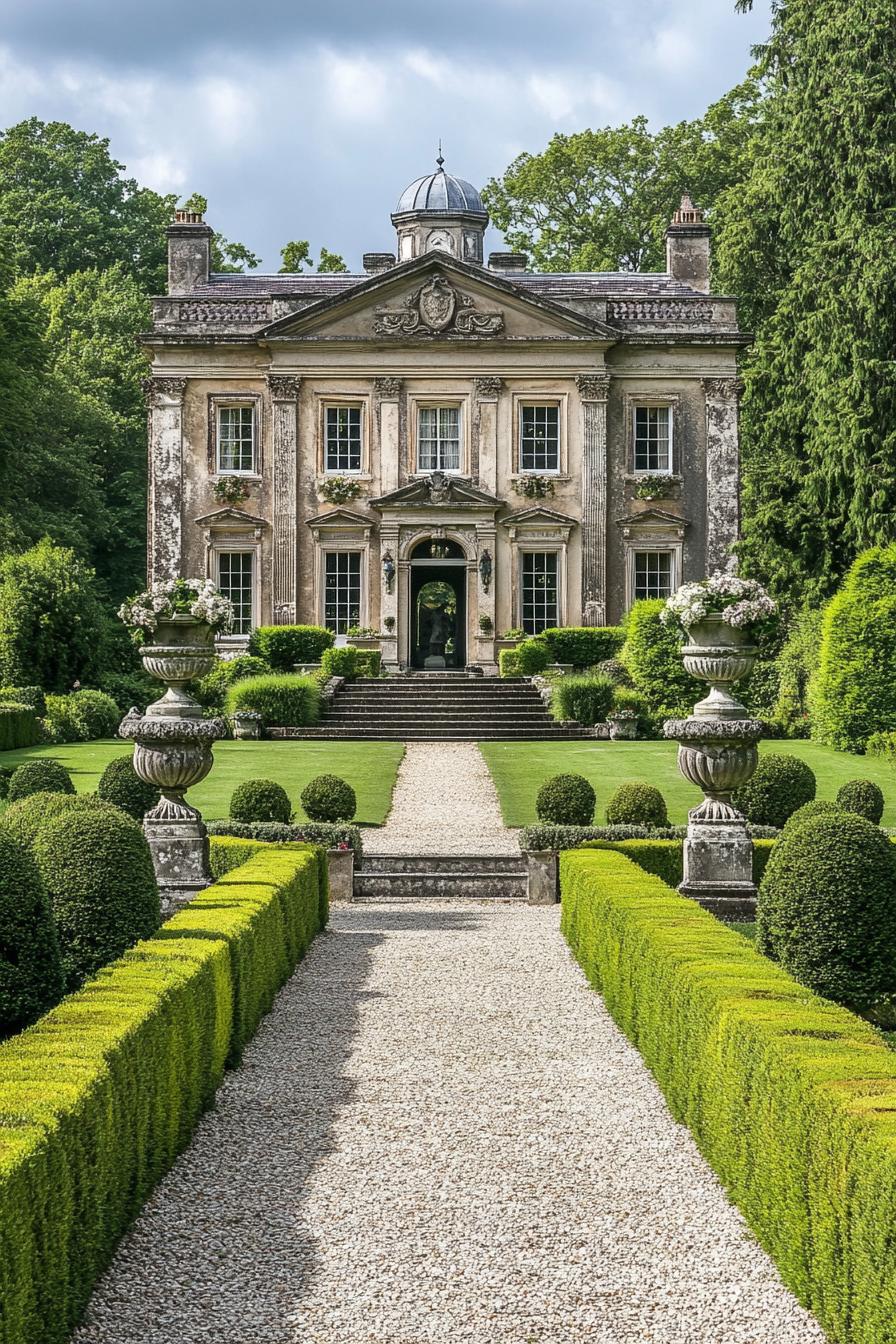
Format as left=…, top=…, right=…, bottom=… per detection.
left=259, top=253, right=619, bottom=344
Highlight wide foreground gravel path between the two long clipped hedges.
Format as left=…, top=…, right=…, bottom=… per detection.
left=75, top=903, right=823, bottom=1344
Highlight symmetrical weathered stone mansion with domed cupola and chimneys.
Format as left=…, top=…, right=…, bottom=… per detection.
left=144, top=159, right=746, bottom=672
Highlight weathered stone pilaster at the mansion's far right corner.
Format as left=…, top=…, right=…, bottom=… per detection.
left=703, top=378, right=742, bottom=574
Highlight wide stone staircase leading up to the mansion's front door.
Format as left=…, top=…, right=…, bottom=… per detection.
left=280, top=672, right=586, bottom=742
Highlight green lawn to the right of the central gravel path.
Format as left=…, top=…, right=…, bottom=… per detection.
left=480, top=741, right=896, bottom=827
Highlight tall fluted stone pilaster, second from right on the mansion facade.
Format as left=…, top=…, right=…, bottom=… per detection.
left=576, top=374, right=610, bottom=625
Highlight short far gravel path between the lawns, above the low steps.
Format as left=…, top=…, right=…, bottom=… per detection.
left=364, top=742, right=520, bottom=857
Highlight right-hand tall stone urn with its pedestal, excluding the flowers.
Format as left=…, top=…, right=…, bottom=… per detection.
left=664, top=616, right=763, bottom=919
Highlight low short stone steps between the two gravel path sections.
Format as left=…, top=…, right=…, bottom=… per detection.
left=352, top=853, right=528, bottom=900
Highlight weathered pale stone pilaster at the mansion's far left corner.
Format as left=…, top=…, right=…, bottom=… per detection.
left=142, top=378, right=187, bottom=583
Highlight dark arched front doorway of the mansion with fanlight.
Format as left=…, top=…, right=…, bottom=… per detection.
left=408, top=539, right=466, bottom=672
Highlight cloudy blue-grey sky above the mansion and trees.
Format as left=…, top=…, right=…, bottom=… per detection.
left=0, top=0, right=768, bottom=270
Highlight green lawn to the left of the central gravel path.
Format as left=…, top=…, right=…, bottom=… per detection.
left=0, top=741, right=404, bottom=825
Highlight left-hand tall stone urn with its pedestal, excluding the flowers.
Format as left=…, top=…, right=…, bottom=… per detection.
left=118, top=616, right=227, bottom=913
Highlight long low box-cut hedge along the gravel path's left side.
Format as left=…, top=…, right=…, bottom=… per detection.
left=0, top=847, right=321, bottom=1344
